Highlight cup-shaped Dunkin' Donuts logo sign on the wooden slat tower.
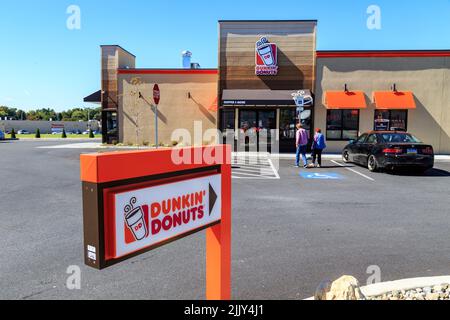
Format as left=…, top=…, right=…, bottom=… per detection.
left=255, top=37, right=278, bottom=76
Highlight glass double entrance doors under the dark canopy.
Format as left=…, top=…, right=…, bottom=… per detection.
left=238, top=109, right=277, bottom=152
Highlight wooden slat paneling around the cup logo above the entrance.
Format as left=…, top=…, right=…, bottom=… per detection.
left=219, top=21, right=316, bottom=92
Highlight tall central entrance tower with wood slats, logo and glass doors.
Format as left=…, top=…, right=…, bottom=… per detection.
left=218, top=21, right=317, bottom=152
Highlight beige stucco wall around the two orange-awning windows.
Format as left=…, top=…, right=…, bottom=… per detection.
left=315, top=57, right=450, bottom=154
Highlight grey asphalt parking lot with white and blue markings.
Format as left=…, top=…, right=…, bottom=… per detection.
left=0, top=141, right=450, bottom=299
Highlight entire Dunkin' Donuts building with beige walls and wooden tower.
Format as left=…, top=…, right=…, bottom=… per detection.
left=87, top=20, right=450, bottom=154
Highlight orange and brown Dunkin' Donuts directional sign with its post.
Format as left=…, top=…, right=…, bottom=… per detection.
left=81, top=145, right=231, bottom=300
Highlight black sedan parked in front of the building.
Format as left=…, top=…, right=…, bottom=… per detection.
left=342, top=131, right=434, bottom=172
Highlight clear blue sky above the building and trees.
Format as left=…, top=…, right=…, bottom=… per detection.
left=0, top=0, right=450, bottom=111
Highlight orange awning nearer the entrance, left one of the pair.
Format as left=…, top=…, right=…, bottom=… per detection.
left=324, top=91, right=367, bottom=109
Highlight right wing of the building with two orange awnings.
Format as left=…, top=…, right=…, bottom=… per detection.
left=315, top=51, right=450, bottom=154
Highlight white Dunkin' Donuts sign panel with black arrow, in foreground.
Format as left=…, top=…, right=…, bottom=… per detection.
left=115, top=175, right=221, bottom=258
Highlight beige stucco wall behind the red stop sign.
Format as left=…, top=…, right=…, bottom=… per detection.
left=118, top=73, right=218, bottom=145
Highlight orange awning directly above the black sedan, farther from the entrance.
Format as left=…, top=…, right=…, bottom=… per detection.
left=373, top=91, right=416, bottom=110
